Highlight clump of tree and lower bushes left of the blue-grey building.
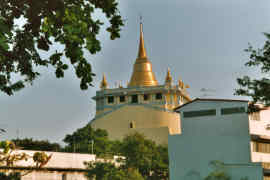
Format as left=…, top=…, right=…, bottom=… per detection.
left=81, top=130, right=169, bottom=180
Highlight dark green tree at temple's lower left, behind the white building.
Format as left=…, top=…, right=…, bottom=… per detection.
left=63, top=124, right=111, bottom=156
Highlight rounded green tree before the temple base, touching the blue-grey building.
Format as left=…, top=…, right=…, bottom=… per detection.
left=121, top=133, right=169, bottom=179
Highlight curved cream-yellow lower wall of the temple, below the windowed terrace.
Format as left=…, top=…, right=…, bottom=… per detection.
left=91, top=105, right=180, bottom=144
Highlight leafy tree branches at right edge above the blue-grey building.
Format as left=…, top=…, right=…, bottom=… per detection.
left=235, top=33, right=270, bottom=105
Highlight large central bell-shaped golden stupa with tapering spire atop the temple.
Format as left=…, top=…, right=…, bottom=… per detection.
left=128, top=23, right=158, bottom=87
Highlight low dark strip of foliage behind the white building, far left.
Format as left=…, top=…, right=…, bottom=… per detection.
left=11, top=138, right=61, bottom=151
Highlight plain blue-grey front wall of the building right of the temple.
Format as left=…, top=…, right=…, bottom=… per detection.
left=169, top=100, right=260, bottom=180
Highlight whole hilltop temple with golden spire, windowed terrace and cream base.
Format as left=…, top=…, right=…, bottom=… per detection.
left=90, top=23, right=191, bottom=144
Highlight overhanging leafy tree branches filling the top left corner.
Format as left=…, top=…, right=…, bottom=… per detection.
left=0, top=0, right=123, bottom=95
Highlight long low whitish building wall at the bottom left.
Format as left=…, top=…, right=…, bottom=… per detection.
left=0, top=150, right=119, bottom=180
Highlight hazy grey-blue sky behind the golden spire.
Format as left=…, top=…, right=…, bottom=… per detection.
left=0, top=0, right=270, bottom=143
